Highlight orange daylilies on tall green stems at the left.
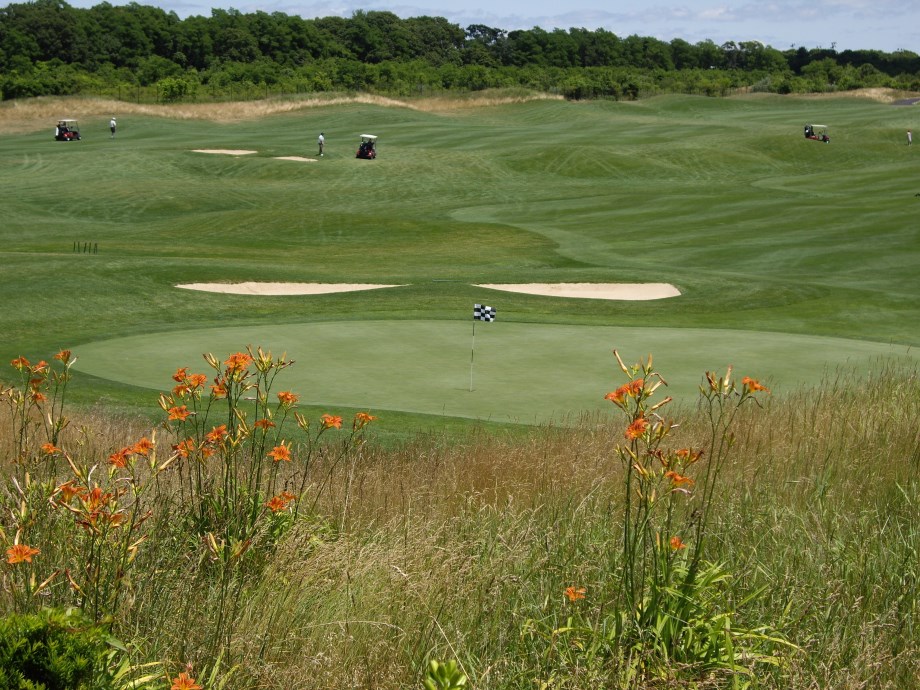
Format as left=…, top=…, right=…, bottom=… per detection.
left=0, top=348, right=375, bottom=658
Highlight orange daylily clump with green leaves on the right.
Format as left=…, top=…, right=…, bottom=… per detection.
left=523, top=350, right=795, bottom=688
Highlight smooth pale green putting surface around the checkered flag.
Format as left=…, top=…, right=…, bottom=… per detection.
left=75, top=320, right=918, bottom=424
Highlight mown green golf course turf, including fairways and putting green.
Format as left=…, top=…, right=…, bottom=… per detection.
left=0, top=96, right=920, bottom=430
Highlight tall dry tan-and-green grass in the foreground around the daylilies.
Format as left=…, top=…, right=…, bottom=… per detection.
left=0, top=358, right=920, bottom=690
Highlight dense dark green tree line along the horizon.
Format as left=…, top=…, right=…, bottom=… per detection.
left=0, top=0, right=920, bottom=101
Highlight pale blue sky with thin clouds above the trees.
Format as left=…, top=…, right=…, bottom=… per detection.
left=69, top=0, right=920, bottom=53
